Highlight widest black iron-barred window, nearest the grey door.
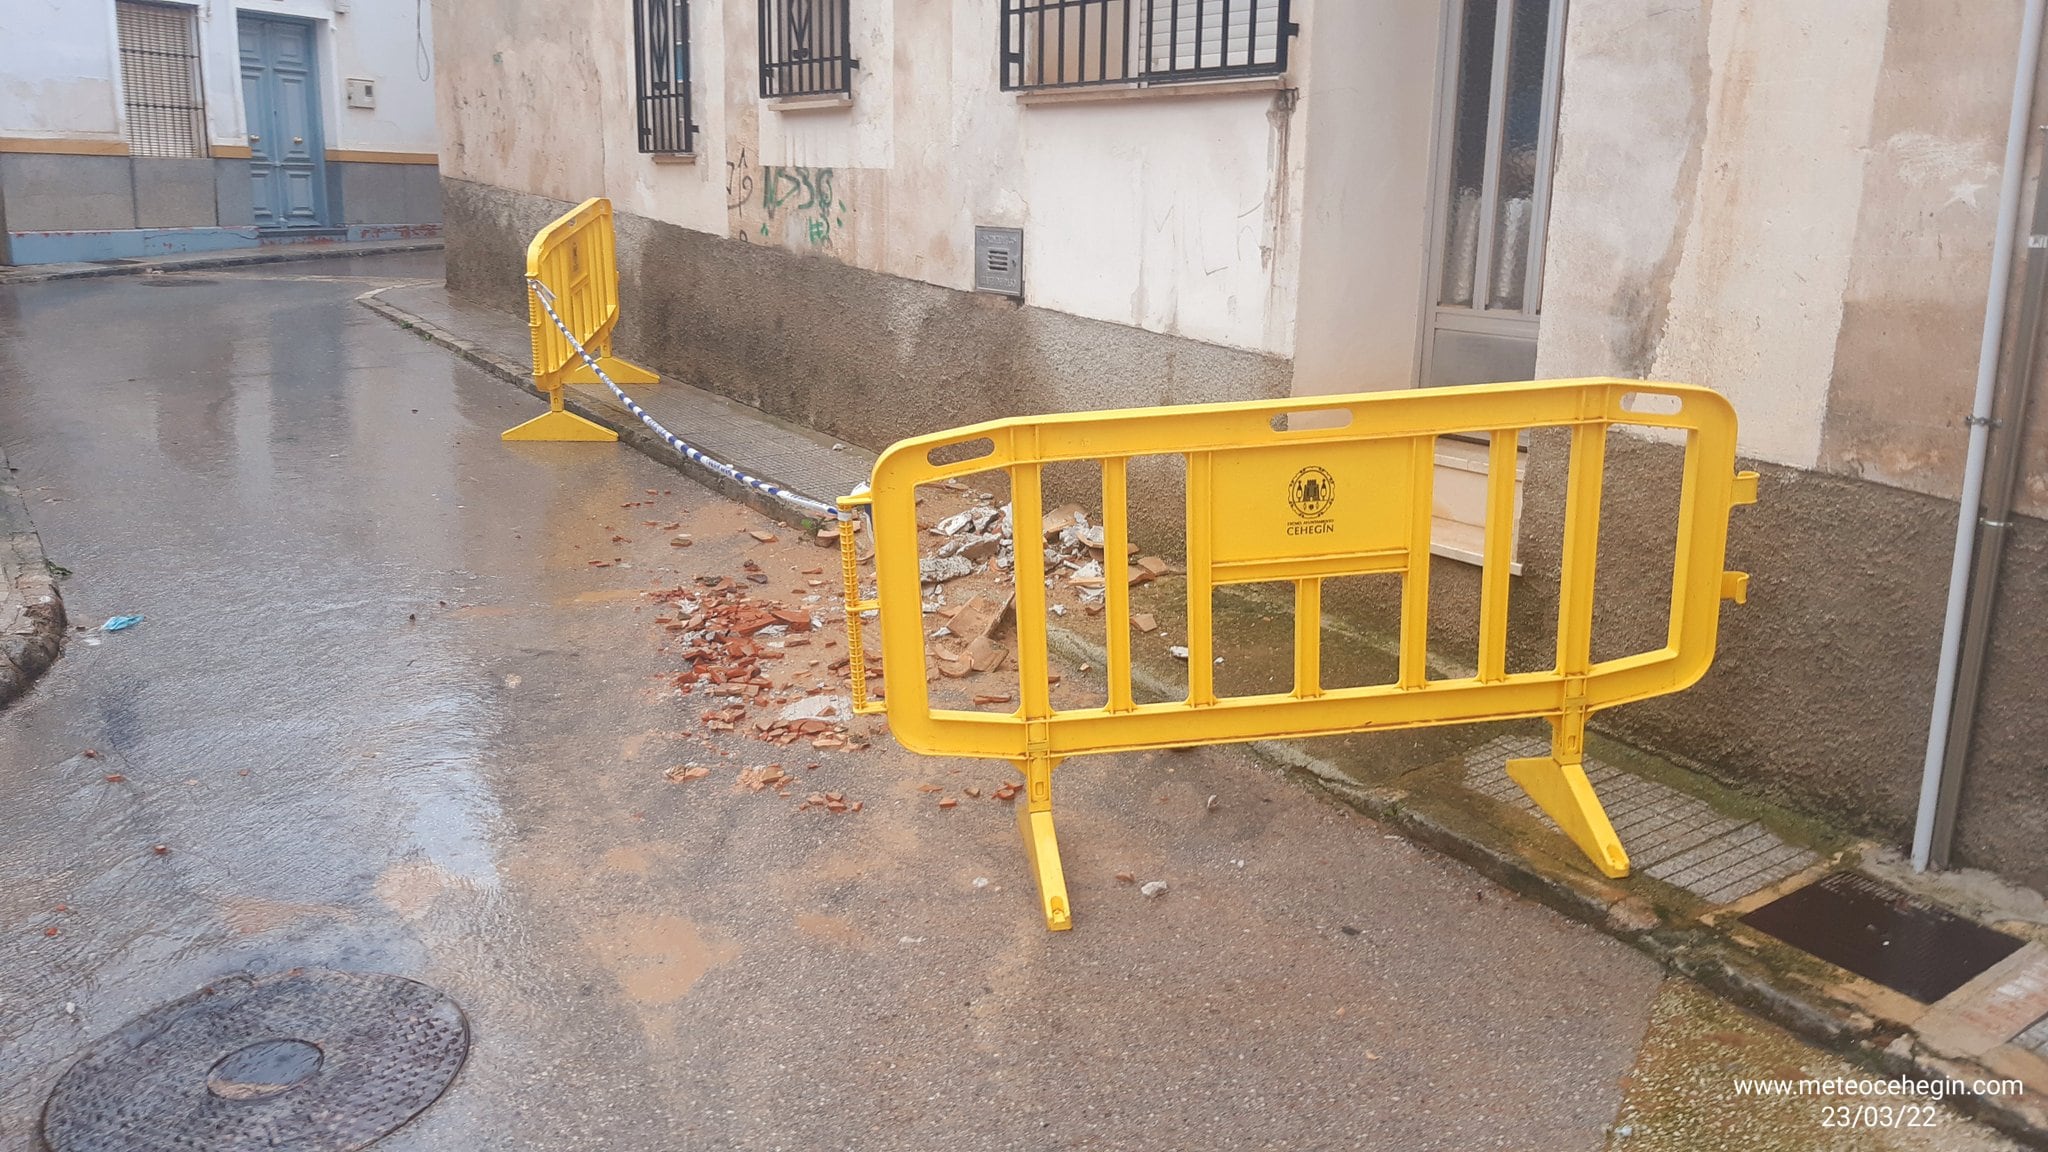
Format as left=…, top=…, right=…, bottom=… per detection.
left=1001, top=0, right=1300, bottom=90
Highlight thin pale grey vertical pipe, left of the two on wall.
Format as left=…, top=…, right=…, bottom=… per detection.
left=1913, top=0, right=2048, bottom=871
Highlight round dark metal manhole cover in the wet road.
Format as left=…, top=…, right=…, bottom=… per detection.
left=43, top=968, right=469, bottom=1152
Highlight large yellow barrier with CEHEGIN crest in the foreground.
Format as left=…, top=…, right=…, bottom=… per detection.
left=840, top=379, right=1757, bottom=929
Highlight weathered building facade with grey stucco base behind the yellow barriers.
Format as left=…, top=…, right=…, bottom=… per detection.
left=438, top=0, right=2048, bottom=883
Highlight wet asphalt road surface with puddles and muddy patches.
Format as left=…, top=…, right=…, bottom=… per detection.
left=0, top=256, right=1659, bottom=1152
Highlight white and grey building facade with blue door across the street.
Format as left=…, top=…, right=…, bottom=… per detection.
left=0, top=0, right=440, bottom=264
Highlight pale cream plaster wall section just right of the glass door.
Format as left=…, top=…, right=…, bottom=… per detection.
left=1536, top=0, right=1888, bottom=467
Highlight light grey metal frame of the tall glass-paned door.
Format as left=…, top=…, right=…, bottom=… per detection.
left=1415, top=0, right=1571, bottom=387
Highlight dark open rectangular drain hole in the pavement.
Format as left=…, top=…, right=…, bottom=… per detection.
left=1743, top=871, right=2025, bottom=1004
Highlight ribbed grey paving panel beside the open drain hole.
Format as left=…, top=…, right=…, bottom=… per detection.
left=1464, top=736, right=1821, bottom=904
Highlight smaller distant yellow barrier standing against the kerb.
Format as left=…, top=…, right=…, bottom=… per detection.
left=502, top=199, right=655, bottom=441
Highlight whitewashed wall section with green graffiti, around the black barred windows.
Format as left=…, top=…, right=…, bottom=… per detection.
left=438, top=0, right=1310, bottom=357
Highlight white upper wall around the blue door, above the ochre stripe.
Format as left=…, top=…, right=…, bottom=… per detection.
left=0, top=0, right=438, bottom=154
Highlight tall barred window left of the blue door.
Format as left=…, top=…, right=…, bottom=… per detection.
left=115, top=0, right=207, bottom=156
